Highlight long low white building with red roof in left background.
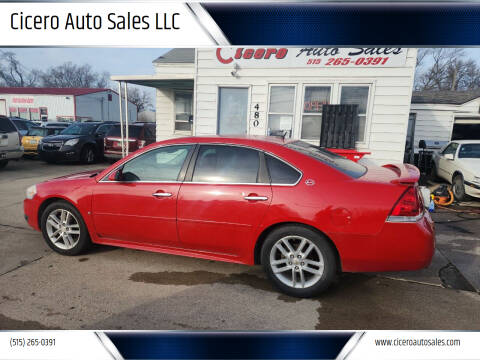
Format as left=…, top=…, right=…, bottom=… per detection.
left=0, top=87, right=137, bottom=121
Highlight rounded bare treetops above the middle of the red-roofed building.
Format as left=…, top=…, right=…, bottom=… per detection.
left=40, top=62, right=110, bottom=88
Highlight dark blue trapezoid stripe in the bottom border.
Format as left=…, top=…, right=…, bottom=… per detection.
left=106, top=332, right=354, bottom=360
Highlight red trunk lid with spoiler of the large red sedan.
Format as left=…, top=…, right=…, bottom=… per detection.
left=360, top=164, right=420, bottom=185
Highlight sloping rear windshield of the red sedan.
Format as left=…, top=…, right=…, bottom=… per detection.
left=286, top=141, right=367, bottom=179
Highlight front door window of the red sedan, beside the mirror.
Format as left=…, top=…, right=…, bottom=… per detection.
left=122, top=145, right=192, bottom=182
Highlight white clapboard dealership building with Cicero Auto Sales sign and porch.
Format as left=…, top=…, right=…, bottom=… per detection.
left=112, top=47, right=417, bottom=164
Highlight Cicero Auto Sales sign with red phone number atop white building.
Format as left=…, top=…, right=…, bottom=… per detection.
left=216, top=47, right=407, bottom=68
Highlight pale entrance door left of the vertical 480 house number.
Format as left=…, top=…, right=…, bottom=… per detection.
left=217, top=87, right=248, bottom=135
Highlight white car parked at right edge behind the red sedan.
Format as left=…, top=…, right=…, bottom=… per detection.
left=432, top=140, right=480, bottom=201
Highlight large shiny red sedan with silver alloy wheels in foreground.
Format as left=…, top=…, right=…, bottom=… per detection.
left=24, top=137, right=434, bottom=297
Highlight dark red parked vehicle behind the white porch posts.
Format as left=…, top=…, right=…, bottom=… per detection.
left=104, top=122, right=156, bottom=162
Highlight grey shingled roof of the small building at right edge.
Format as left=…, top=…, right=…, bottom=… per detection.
left=412, top=90, right=480, bottom=105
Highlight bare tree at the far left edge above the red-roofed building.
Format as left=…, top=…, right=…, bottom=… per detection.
left=0, top=52, right=40, bottom=87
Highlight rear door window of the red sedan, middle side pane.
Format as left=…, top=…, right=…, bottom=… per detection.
left=192, top=145, right=260, bottom=184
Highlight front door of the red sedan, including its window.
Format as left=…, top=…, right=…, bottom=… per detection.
left=92, top=145, right=193, bottom=246
